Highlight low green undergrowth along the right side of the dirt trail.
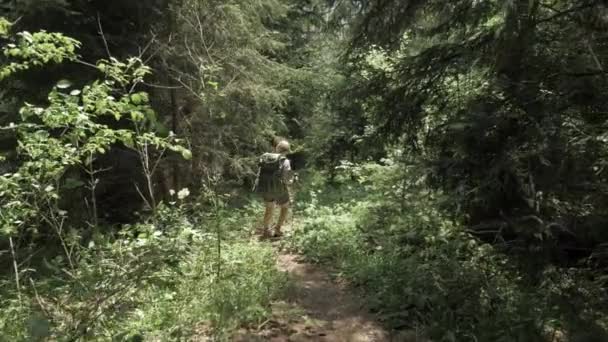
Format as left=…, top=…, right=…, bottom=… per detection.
left=288, top=160, right=608, bottom=342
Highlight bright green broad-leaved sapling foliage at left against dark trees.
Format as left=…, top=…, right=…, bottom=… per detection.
left=0, top=54, right=190, bottom=235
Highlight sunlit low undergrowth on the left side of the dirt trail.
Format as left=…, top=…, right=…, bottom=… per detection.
left=0, top=199, right=286, bottom=342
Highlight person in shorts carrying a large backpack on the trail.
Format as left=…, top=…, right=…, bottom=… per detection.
left=255, top=140, right=293, bottom=237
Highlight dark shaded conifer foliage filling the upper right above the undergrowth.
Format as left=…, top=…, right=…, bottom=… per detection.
left=332, top=0, right=608, bottom=264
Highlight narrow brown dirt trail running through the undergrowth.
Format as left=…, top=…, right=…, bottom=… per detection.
left=234, top=248, right=394, bottom=342
